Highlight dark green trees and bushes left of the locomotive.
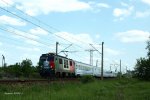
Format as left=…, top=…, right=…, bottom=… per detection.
left=0, top=59, right=40, bottom=79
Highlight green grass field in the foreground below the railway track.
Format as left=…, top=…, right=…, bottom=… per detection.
left=0, top=79, right=150, bottom=100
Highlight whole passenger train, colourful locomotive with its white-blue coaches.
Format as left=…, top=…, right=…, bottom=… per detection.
left=39, top=53, right=117, bottom=77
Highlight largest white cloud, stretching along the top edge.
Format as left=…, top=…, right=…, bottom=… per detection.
left=14, top=0, right=91, bottom=16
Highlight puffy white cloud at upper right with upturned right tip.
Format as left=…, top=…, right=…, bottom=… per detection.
left=113, top=6, right=134, bottom=20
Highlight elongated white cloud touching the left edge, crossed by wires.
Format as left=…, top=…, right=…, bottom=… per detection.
left=0, top=15, right=26, bottom=26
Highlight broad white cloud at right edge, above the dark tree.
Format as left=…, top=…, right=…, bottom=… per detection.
left=116, top=30, right=150, bottom=43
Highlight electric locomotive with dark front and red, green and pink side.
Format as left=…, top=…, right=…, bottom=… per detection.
left=39, top=53, right=75, bottom=77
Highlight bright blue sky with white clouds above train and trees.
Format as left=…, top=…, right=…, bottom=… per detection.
left=0, top=0, right=150, bottom=71
